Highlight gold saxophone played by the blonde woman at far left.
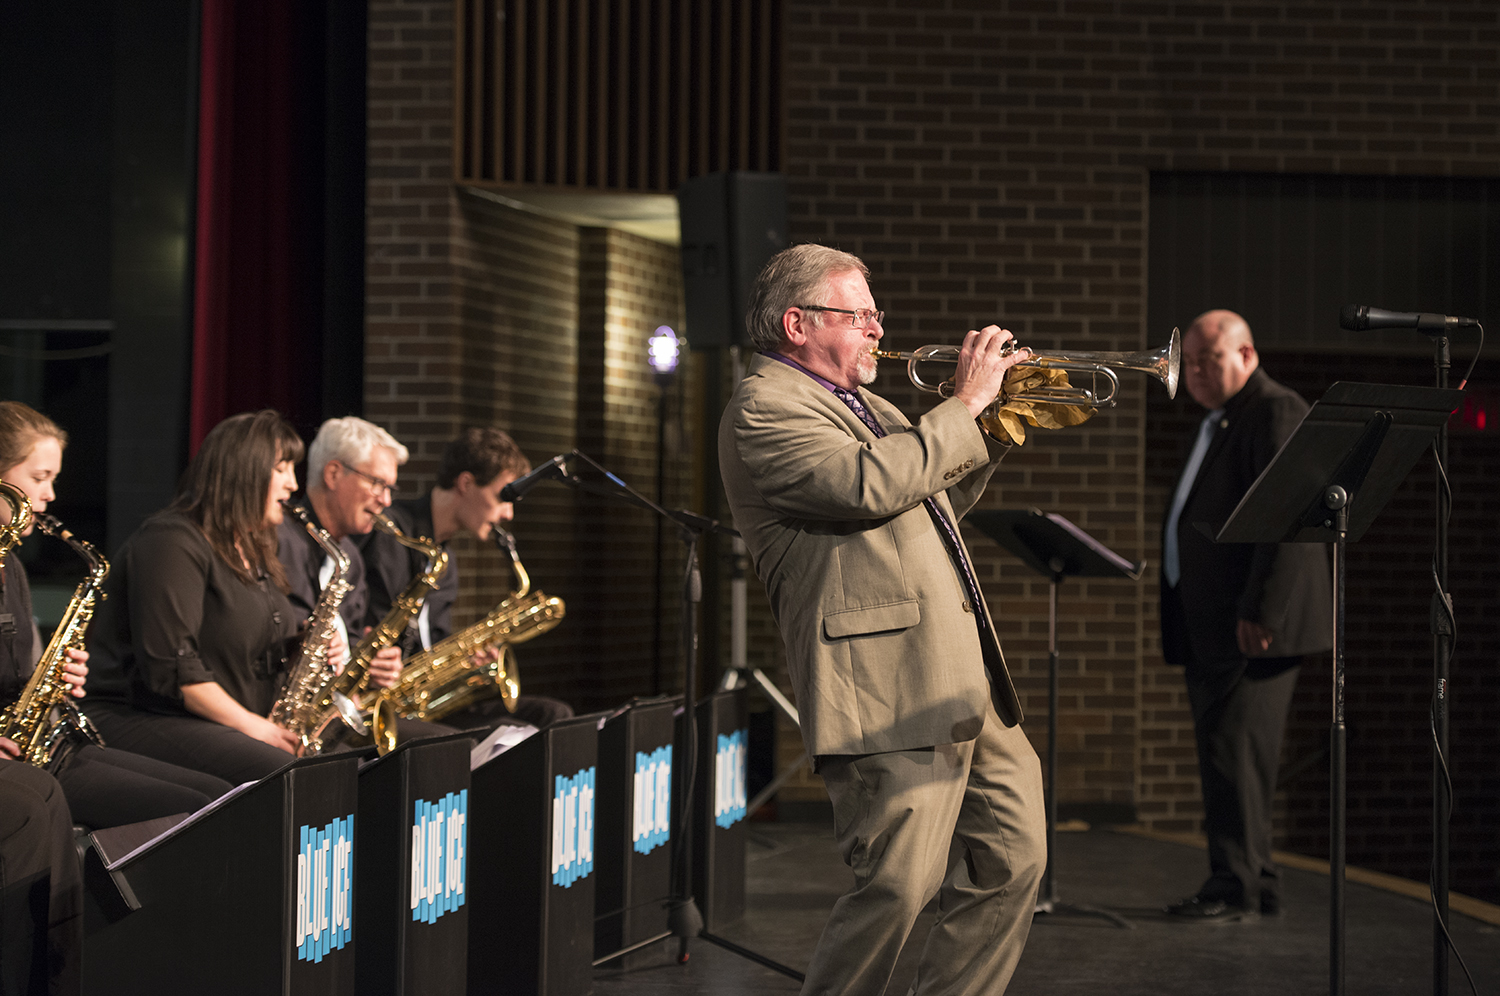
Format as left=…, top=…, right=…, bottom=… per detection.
left=0, top=506, right=110, bottom=768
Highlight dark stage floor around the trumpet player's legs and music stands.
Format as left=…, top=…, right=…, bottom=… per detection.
left=594, top=824, right=1500, bottom=996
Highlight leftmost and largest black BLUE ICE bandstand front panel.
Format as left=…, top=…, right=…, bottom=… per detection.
left=83, top=755, right=359, bottom=996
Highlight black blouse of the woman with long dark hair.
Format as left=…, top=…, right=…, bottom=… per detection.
left=89, top=512, right=297, bottom=716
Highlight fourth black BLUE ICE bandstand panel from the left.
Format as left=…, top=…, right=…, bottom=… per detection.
left=594, top=696, right=683, bottom=959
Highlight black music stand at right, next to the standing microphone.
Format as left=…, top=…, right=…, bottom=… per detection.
left=1212, top=381, right=1464, bottom=996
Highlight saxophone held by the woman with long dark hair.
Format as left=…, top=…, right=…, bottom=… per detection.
left=270, top=506, right=354, bottom=756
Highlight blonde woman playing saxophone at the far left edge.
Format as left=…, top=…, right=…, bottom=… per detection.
left=0, top=401, right=230, bottom=830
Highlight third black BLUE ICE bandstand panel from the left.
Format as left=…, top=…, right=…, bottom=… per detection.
left=468, top=714, right=603, bottom=996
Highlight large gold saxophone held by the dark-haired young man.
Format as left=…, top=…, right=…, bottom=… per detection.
left=372, top=527, right=567, bottom=720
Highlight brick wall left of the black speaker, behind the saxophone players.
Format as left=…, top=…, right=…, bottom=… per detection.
left=365, top=0, right=690, bottom=710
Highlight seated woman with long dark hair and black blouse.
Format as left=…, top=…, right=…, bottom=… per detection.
left=89, top=410, right=303, bottom=782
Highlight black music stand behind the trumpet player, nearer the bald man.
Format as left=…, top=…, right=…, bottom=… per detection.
left=965, top=509, right=1146, bottom=930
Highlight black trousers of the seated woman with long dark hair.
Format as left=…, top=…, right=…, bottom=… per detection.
left=86, top=702, right=293, bottom=785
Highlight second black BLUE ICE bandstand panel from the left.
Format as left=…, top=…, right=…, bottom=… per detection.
left=354, top=734, right=474, bottom=996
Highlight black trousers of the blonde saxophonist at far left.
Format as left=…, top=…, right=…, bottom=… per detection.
left=56, top=744, right=233, bottom=830
